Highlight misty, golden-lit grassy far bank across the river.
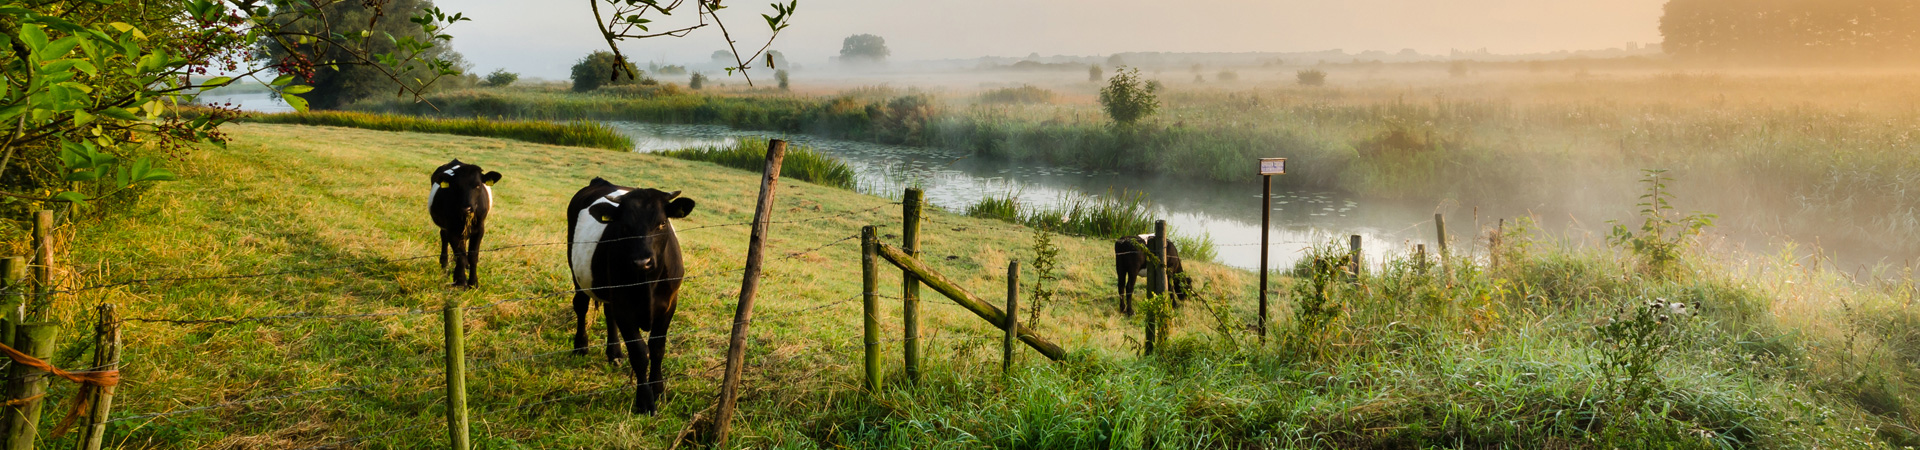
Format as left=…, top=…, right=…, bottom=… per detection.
left=355, top=75, right=1920, bottom=265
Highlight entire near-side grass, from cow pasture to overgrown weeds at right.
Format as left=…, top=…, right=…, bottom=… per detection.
left=26, top=123, right=1920, bottom=448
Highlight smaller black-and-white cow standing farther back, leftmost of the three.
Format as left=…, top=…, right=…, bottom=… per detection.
left=426, top=160, right=499, bottom=287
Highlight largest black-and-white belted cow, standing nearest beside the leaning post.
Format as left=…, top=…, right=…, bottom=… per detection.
left=566, top=179, right=693, bottom=413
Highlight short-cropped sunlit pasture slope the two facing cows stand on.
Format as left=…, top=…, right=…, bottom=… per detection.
left=60, top=125, right=1250, bottom=448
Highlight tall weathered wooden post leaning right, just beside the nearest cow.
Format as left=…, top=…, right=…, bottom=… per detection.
left=714, top=138, right=787, bottom=446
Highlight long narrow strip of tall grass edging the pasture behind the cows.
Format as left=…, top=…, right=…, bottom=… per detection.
left=240, top=112, right=634, bottom=150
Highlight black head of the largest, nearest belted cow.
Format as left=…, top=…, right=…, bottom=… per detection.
left=588, top=188, right=693, bottom=271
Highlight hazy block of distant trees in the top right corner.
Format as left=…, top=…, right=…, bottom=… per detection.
left=1661, top=0, right=1920, bottom=63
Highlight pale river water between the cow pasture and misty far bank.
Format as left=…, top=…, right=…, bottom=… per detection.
left=609, top=121, right=1432, bottom=269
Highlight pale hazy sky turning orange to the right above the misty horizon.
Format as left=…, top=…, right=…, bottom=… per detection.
left=436, top=0, right=1665, bottom=79
